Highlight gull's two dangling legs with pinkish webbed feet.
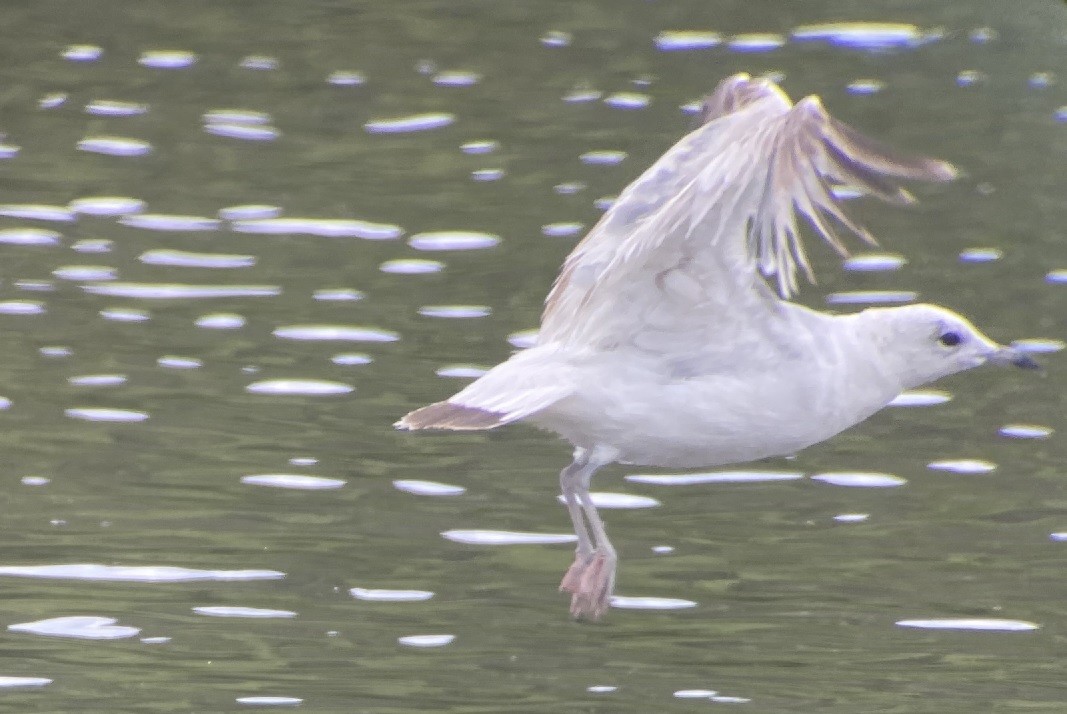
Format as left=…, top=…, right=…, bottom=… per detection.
left=559, top=449, right=618, bottom=620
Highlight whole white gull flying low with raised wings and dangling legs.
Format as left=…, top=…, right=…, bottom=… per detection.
left=395, top=75, right=1037, bottom=620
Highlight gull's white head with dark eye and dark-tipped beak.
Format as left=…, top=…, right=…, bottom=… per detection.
left=860, top=304, right=1040, bottom=390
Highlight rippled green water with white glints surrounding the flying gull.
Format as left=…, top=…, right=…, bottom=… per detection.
left=0, top=0, right=1067, bottom=713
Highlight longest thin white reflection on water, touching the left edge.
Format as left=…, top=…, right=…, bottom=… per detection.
left=0, top=562, right=285, bottom=583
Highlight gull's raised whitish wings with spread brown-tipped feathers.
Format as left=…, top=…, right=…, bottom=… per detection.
left=539, top=75, right=956, bottom=351
